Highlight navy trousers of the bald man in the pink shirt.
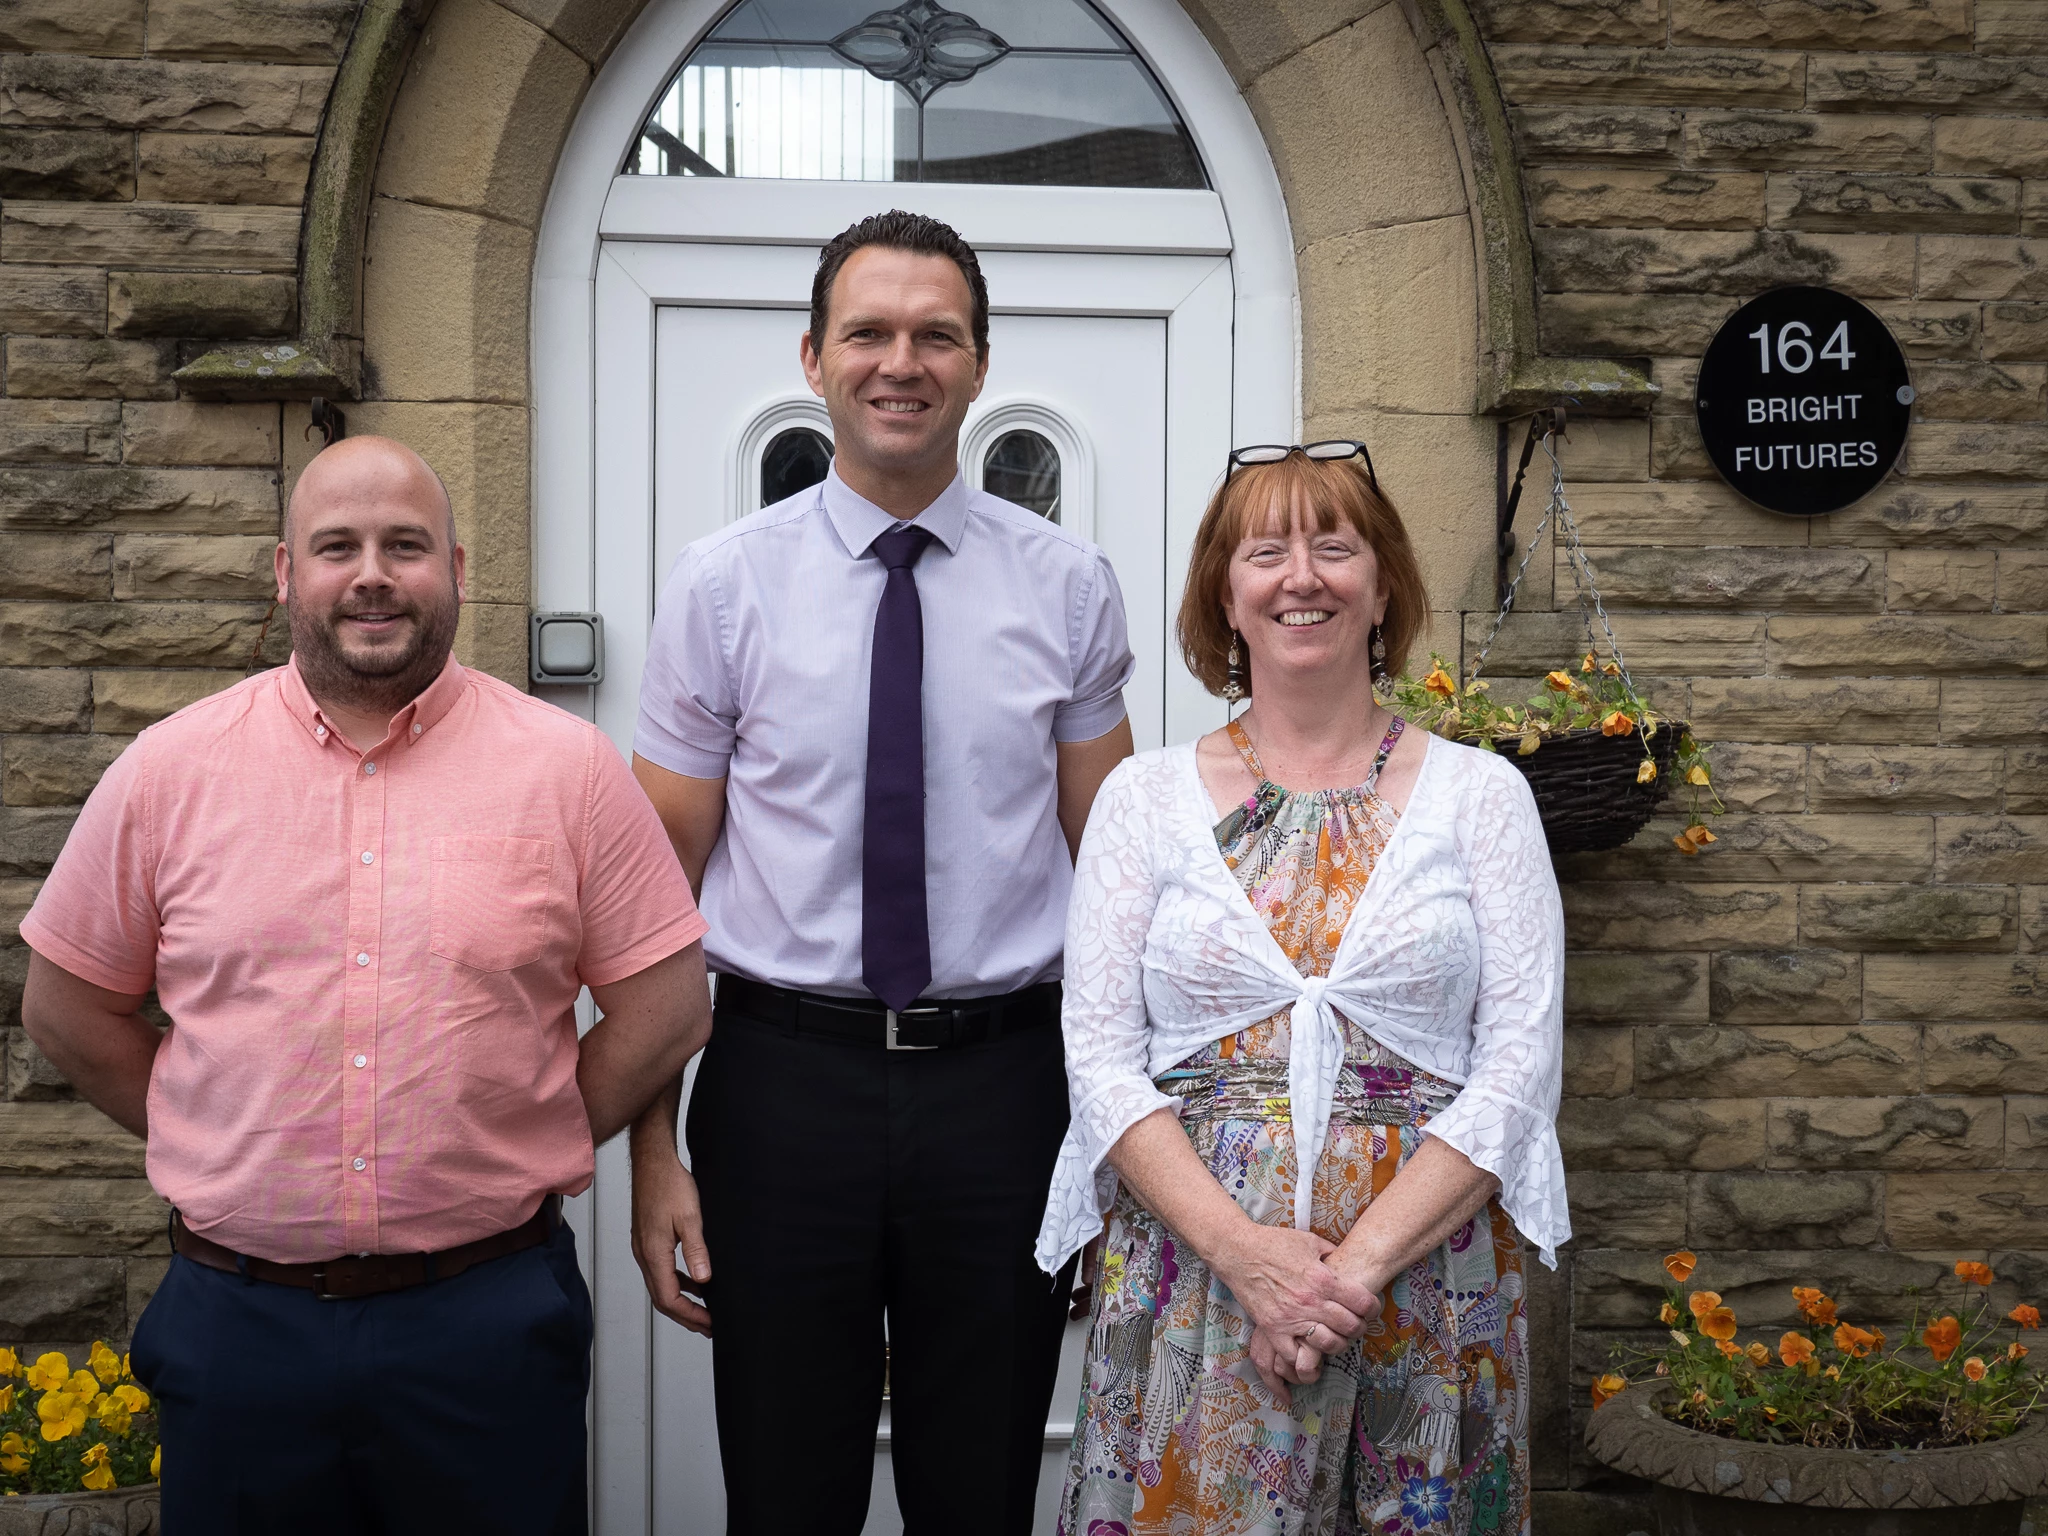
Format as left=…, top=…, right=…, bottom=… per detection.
left=131, top=1227, right=590, bottom=1536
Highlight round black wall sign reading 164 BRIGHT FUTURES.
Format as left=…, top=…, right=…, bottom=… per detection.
left=1696, top=289, right=1913, bottom=516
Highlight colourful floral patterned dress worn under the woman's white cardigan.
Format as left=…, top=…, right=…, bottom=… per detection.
left=1059, top=721, right=1528, bottom=1536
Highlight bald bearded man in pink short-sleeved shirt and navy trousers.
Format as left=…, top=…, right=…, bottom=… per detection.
left=23, top=438, right=711, bottom=1536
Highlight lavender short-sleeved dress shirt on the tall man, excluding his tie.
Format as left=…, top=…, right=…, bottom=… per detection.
left=633, top=471, right=1137, bottom=997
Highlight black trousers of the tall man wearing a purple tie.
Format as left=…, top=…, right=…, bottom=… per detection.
left=686, top=1006, right=1069, bottom=1536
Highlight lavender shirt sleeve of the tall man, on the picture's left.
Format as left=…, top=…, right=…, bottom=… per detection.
left=633, top=549, right=739, bottom=778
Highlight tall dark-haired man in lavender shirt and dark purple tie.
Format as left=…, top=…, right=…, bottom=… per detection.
left=633, top=213, right=1133, bottom=1536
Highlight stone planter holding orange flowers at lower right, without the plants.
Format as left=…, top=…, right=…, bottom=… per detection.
left=1585, top=1386, right=2048, bottom=1536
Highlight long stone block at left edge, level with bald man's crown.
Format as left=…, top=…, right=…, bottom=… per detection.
left=0, top=466, right=279, bottom=537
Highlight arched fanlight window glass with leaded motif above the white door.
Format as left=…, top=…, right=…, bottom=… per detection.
left=625, top=0, right=1208, bottom=186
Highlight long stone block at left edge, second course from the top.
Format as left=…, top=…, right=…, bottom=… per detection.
left=0, top=53, right=334, bottom=133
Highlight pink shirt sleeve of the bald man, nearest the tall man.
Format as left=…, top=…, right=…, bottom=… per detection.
left=575, top=733, right=711, bottom=987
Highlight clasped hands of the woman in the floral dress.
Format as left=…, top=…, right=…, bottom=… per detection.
left=1212, top=1221, right=1380, bottom=1407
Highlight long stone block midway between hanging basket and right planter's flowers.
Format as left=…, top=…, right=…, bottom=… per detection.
left=1636, top=1024, right=1919, bottom=1102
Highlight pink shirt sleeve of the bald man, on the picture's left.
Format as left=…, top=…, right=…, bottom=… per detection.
left=20, top=735, right=162, bottom=997
